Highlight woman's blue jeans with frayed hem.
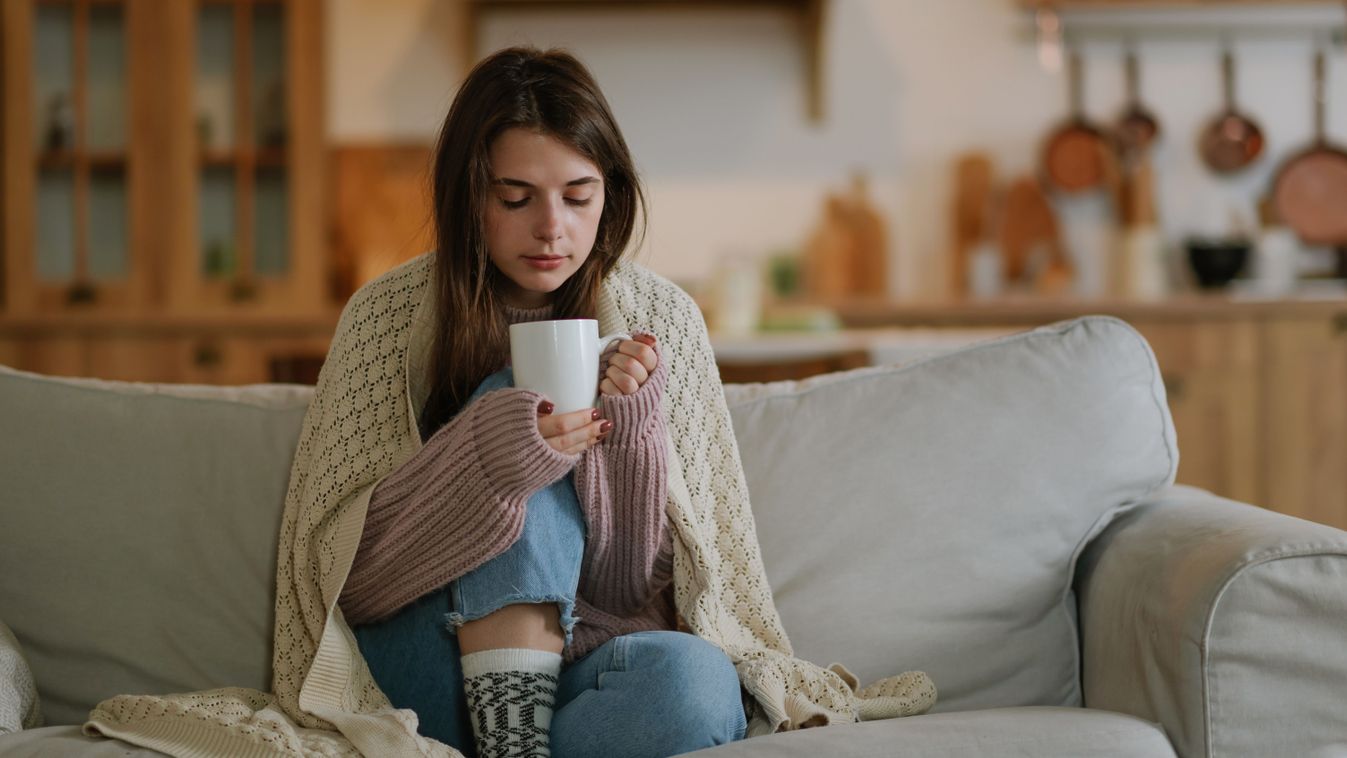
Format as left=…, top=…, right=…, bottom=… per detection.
left=353, top=369, right=746, bottom=758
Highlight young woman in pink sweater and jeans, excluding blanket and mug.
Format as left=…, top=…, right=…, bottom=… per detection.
left=341, top=48, right=746, bottom=758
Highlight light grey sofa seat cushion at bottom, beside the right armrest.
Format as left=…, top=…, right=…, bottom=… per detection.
left=684, top=707, right=1175, bottom=758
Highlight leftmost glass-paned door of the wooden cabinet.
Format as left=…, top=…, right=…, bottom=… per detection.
left=3, top=0, right=155, bottom=312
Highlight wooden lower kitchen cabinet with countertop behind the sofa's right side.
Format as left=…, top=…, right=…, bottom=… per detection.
left=830, top=296, right=1347, bottom=529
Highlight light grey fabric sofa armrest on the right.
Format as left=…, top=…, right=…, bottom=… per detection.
left=1076, top=486, right=1347, bottom=758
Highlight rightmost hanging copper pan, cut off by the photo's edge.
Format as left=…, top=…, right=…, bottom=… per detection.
left=1273, top=50, right=1347, bottom=245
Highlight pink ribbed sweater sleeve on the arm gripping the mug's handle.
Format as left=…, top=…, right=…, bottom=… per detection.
left=575, top=347, right=674, bottom=615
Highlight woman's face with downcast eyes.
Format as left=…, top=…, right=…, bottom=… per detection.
left=484, top=128, right=603, bottom=307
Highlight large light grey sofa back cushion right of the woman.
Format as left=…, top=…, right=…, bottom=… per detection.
left=726, top=316, right=1177, bottom=712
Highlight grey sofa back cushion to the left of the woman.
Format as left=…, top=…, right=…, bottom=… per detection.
left=0, top=368, right=313, bottom=724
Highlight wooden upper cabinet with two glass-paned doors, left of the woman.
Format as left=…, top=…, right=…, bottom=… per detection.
left=0, top=0, right=329, bottom=318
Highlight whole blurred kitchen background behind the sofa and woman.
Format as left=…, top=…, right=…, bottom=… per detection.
left=0, top=0, right=1347, bottom=528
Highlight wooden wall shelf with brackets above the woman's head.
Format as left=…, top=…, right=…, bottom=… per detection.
left=463, top=0, right=828, bottom=124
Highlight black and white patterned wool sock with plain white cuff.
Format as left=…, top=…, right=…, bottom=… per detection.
left=462, top=648, right=562, bottom=758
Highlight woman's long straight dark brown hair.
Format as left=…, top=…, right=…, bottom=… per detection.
left=420, top=47, right=645, bottom=435
